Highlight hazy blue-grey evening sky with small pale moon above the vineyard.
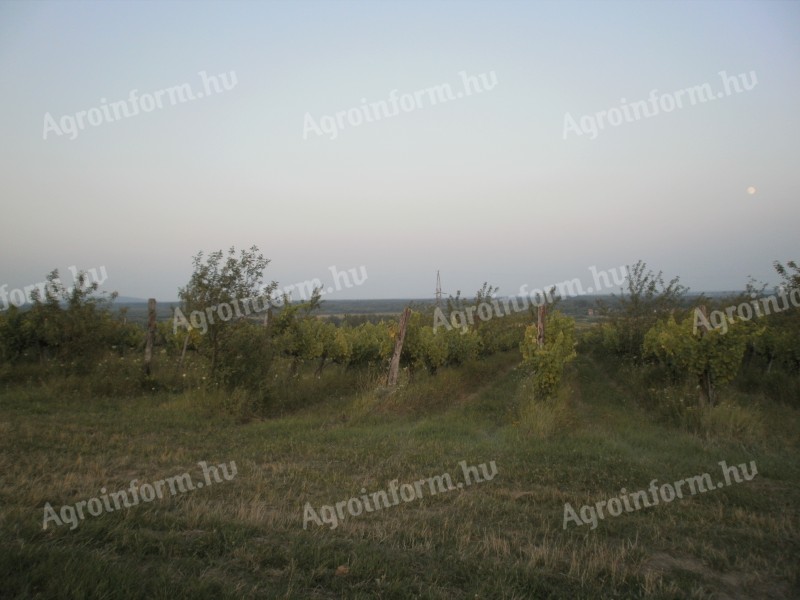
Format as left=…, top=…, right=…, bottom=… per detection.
left=0, top=0, right=800, bottom=301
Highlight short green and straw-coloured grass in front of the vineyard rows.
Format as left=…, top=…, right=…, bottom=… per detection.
left=0, top=353, right=800, bottom=599
